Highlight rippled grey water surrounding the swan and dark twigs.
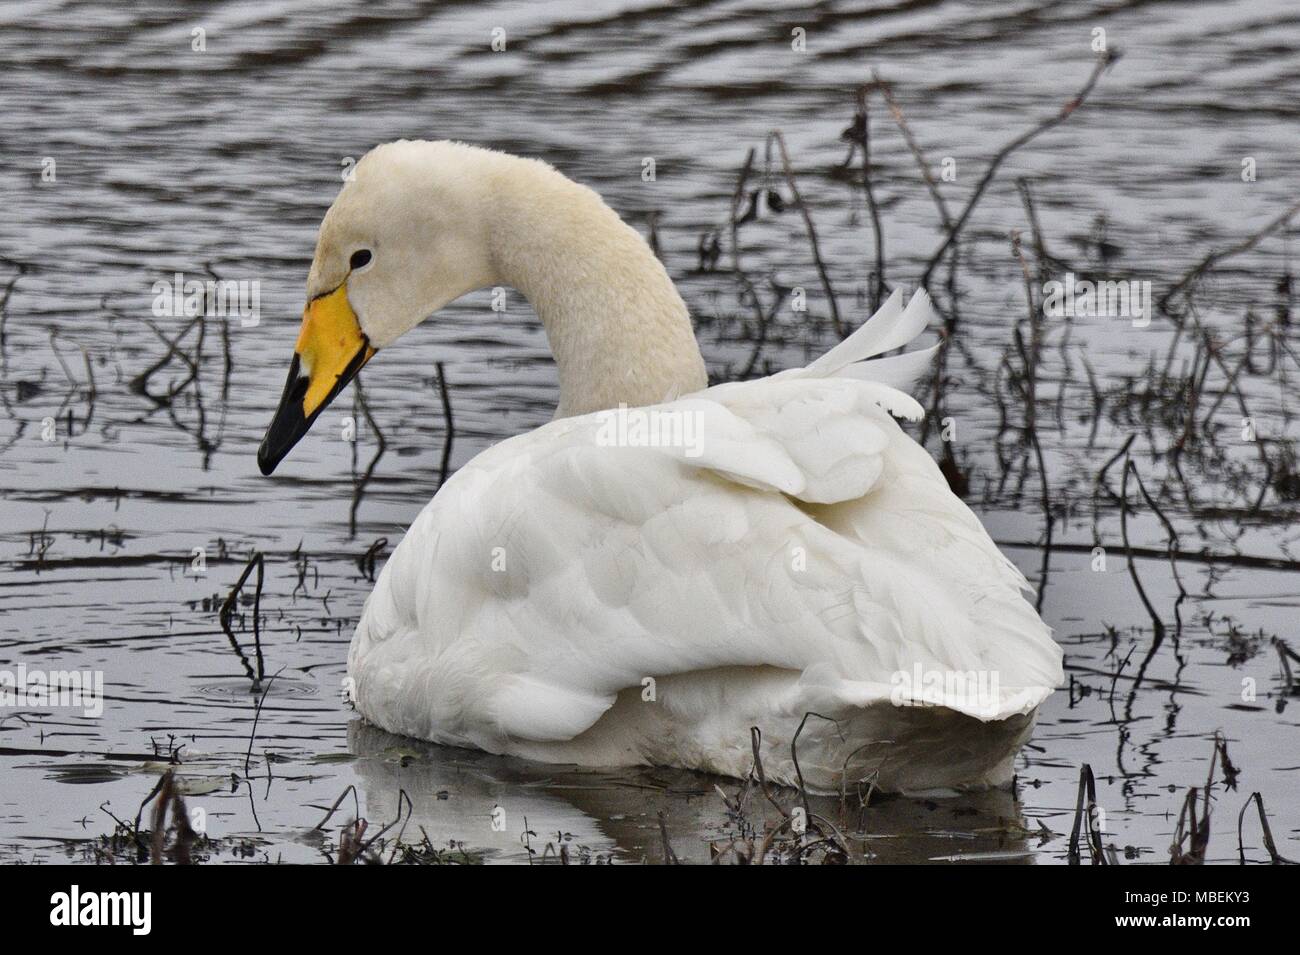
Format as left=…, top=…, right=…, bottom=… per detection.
left=0, top=1, right=1300, bottom=863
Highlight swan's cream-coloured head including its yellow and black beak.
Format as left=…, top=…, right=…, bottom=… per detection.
left=257, top=140, right=502, bottom=474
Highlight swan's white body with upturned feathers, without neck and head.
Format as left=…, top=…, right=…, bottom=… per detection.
left=348, top=291, right=1061, bottom=789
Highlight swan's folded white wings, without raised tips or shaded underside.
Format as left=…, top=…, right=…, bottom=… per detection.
left=350, top=378, right=1060, bottom=751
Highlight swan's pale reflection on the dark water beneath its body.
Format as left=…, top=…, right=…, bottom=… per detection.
left=335, top=720, right=1034, bottom=863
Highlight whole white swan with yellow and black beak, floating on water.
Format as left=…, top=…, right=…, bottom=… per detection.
left=259, top=142, right=1062, bottom=791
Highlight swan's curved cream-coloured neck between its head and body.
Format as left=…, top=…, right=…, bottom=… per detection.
left=490, top=157, right=707, bottom=417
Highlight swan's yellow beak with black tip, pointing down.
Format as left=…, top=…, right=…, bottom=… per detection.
left=257, top=283, right=374, bottom=474
